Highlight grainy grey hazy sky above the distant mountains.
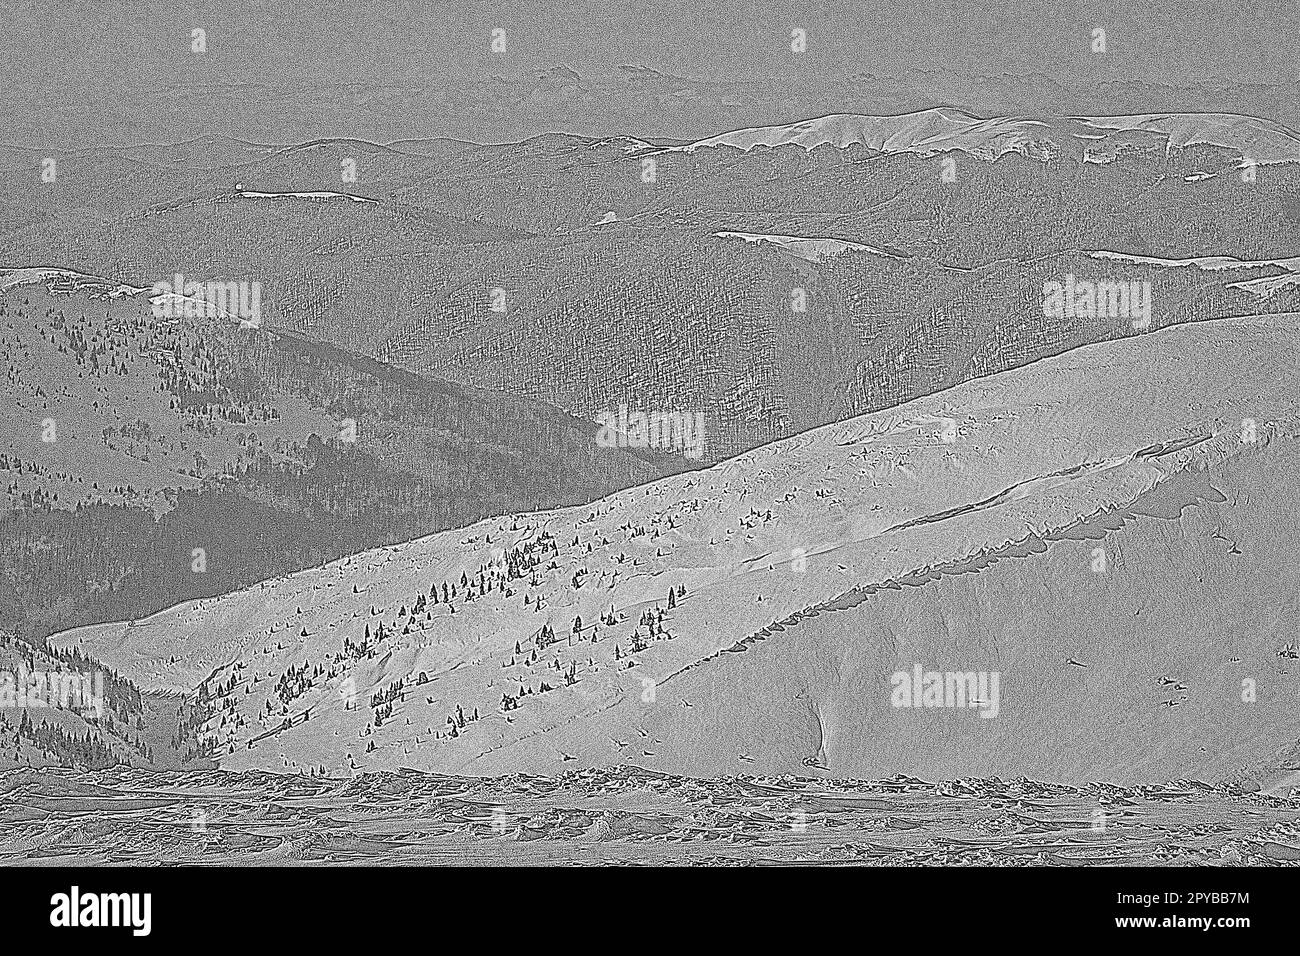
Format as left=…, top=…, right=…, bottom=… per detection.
left=0, top=0, right=1300, bottom=146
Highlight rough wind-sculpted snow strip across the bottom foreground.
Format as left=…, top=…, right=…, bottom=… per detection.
left=0, top=769, right=1300, bottom=866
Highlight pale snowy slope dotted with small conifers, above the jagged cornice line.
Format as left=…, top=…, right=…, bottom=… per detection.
left=52, top=313, right=1300, bottom=773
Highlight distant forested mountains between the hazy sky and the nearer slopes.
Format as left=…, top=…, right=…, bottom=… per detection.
left=0, top=109, right=1300, bottom=470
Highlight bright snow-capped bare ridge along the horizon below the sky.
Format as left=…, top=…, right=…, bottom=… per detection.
left=672, top=108, right=1300, bottom=164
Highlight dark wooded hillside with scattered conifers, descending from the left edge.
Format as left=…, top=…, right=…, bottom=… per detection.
left=0, top=271, right=692, bottom=645
